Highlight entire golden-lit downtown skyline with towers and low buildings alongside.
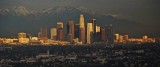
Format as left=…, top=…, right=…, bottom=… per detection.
left=1, top=14, right=156, bottom=46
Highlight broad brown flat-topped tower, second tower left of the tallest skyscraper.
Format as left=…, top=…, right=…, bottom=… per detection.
left=67, top=21, right=74, bottom=42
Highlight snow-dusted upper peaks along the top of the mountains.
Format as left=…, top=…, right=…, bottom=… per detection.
left=0, top=6, right=95, bottom=16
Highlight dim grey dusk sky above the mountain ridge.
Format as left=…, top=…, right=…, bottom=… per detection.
left=0, top=0, right=160, bottom=36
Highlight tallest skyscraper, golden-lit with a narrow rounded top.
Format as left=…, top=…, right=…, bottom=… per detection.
left=79, top=14, right=85, bottom=43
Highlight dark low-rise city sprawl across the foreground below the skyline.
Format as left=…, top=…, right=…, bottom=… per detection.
left=0, top=44, right=160, bottom=67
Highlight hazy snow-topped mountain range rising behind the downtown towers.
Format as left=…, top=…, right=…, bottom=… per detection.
left=0, top=6, right=142, bottom=37
